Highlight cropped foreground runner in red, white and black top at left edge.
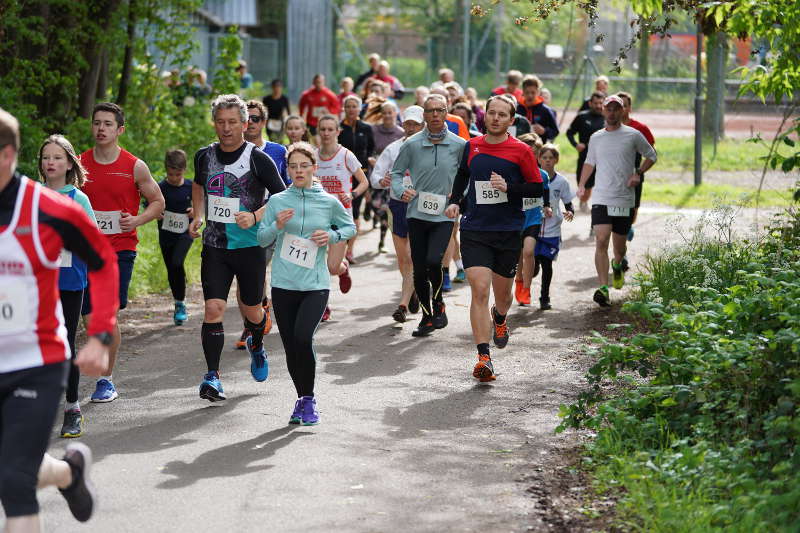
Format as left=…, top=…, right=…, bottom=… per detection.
left=0, top=109, right=119, bottom=532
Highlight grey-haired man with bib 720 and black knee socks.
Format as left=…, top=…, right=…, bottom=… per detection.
left=189, top=94, right=285, bottom=402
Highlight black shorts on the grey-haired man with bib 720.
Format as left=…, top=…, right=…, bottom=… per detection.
left=200, top=245, right=267, bottom=305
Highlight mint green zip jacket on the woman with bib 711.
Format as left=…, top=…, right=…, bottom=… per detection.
left=258, top=183, right=356, bottom=291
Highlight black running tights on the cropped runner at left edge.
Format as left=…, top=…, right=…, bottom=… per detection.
left=0, top=361, right=69, bottom=518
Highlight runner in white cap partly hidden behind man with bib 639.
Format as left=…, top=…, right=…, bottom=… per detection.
left=369, top=106, right=425, bottom=323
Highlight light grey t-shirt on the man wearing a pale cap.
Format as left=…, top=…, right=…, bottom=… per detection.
left=588, top=125, right=656, bottom=207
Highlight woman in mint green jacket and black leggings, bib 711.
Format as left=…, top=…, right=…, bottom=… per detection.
left=258, top=142, right=356, bottom=426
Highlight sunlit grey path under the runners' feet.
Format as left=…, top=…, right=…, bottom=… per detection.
left=40, top=203, right=764, bottom=533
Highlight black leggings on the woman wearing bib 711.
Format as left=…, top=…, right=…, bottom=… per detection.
left=272, top=287, right=330, bottom=398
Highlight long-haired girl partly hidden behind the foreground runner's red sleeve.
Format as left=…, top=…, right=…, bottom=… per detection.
left=39, top=135, right=97, bottom=438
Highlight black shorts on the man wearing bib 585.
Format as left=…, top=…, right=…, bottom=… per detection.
left=461, top=230, right=522, bottom=278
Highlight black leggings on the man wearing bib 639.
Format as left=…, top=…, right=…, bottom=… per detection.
left=408, top=218, right=453, bottom=316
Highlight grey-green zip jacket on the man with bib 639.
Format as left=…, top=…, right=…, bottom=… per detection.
left=391, top=129, right=467, bottom=222
